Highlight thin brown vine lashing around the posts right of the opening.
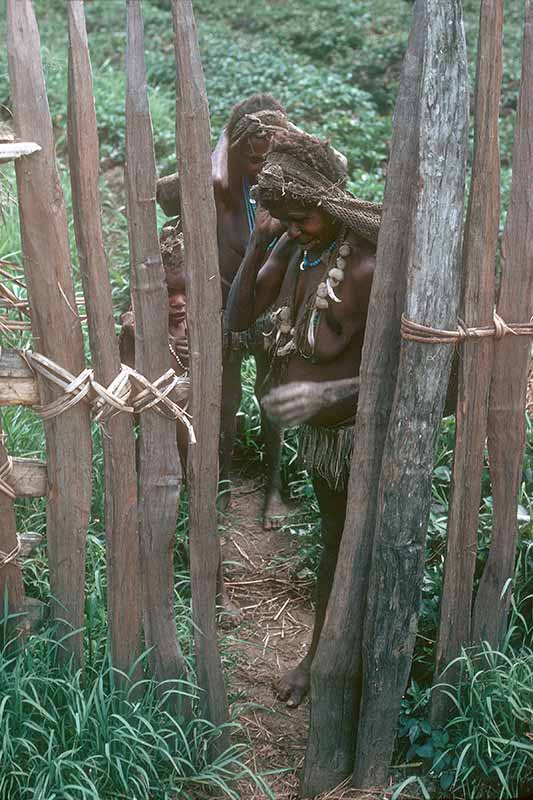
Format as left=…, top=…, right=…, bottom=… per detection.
left=400, top=311, right=533, bottom=344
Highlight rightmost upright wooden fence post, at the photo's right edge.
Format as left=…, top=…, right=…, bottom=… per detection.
left=472, top=0, right=533, bottom=647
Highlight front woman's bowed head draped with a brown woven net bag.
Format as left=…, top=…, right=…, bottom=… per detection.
left=255, top=130, right=381, bottom=249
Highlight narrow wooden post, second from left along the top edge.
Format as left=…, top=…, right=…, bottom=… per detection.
left=67, top=0, right=142, bottom=672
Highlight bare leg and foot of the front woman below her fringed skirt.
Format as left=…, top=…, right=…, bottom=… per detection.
left=278, top=477, right=347, bottom=707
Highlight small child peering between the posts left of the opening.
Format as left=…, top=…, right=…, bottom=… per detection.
left=119, top=222, right=242, bottom=624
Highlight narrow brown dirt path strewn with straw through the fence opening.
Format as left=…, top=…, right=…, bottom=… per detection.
left=218, top=479, right=313, bottom=800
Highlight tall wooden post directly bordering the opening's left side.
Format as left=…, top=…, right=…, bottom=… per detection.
left=172, top=0, right=229, bottom=736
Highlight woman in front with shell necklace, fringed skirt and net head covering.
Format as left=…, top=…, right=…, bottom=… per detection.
left=228, top=132, right=381, bottom=706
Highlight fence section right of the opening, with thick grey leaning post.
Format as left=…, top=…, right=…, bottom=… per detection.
left=303, top=0, right=533, bottom=796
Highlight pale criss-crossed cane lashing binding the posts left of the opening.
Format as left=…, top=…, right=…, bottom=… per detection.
left=21, top=350, right=196, bottom=444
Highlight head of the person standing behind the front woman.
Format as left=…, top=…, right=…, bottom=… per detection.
left=227, top=94, right=287, bottom=184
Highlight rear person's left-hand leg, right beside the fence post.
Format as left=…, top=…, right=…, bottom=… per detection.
left=219, top=348, right=242, bottom=511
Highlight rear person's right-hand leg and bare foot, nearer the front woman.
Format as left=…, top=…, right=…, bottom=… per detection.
left=254, top=347, right=288, bottom=530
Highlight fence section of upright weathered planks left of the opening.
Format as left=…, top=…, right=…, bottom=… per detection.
left=0, top=0, right=228, bottom=732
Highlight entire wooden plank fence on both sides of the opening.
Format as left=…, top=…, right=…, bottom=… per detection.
left=0, top=0, right=533, bottom=794
